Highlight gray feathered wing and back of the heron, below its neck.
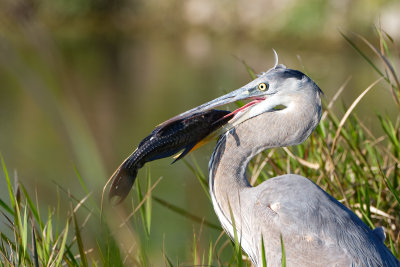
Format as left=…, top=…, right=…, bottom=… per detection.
left=243, top=175, right=400, bottom=266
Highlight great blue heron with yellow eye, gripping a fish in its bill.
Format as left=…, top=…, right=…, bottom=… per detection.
left=108, top=55, right=400, bottom=266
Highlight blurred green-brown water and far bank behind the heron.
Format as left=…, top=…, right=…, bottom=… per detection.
left=0, top=0, right=400, bottom=266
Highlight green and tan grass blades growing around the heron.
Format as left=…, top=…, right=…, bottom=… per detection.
left=0, top=30, right=400, bottom=266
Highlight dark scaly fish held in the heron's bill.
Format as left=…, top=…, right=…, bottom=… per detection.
left=109, top=109, right=233, bottom=203
